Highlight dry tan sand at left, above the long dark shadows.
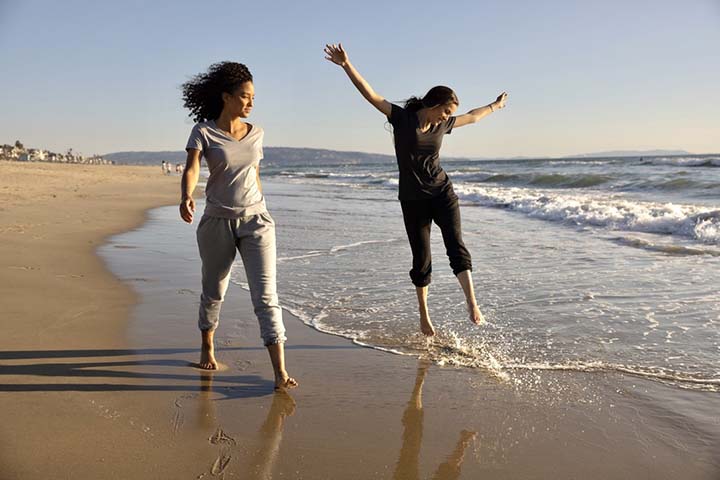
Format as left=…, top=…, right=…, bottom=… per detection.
left=0, top=162, right=180, bottom=349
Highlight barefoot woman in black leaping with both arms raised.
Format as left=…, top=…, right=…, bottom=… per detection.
left=325, top=44, right=507, bottom=336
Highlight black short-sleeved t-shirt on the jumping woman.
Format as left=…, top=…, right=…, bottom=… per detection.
left=389, top=105, right=455, bottom=200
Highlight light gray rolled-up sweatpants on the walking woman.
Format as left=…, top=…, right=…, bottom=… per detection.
left=197, top=213, right=286, bottom=346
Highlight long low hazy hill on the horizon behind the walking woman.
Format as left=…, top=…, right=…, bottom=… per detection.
left=103, top=147, right=395, bottom=166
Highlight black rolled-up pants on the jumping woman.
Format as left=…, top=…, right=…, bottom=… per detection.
left=400, top=195, right=472, bottom=287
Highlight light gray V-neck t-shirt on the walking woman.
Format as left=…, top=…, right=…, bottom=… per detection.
left=185, top=120, right=266, bottom=218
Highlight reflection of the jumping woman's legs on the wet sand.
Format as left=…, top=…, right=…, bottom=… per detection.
left=393, top=360, right=477, bottom=480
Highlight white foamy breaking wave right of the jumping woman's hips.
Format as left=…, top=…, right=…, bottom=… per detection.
left=455, top=185, right=720, bottom=245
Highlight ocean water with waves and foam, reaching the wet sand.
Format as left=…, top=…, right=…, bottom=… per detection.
left=201, top=155, right=720, bottom=391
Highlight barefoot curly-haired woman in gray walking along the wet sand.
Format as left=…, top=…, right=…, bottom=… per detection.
left=180, top=62, right=297, bottom=389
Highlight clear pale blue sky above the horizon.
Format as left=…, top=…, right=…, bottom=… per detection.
left=0, top=0, right=720, bottom=157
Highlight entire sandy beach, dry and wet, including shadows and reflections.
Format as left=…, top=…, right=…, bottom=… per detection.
left=0, top=163, right=720, bottom=480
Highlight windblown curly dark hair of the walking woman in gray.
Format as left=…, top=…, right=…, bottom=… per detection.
left=182, top=62, right=252, bottom=122
